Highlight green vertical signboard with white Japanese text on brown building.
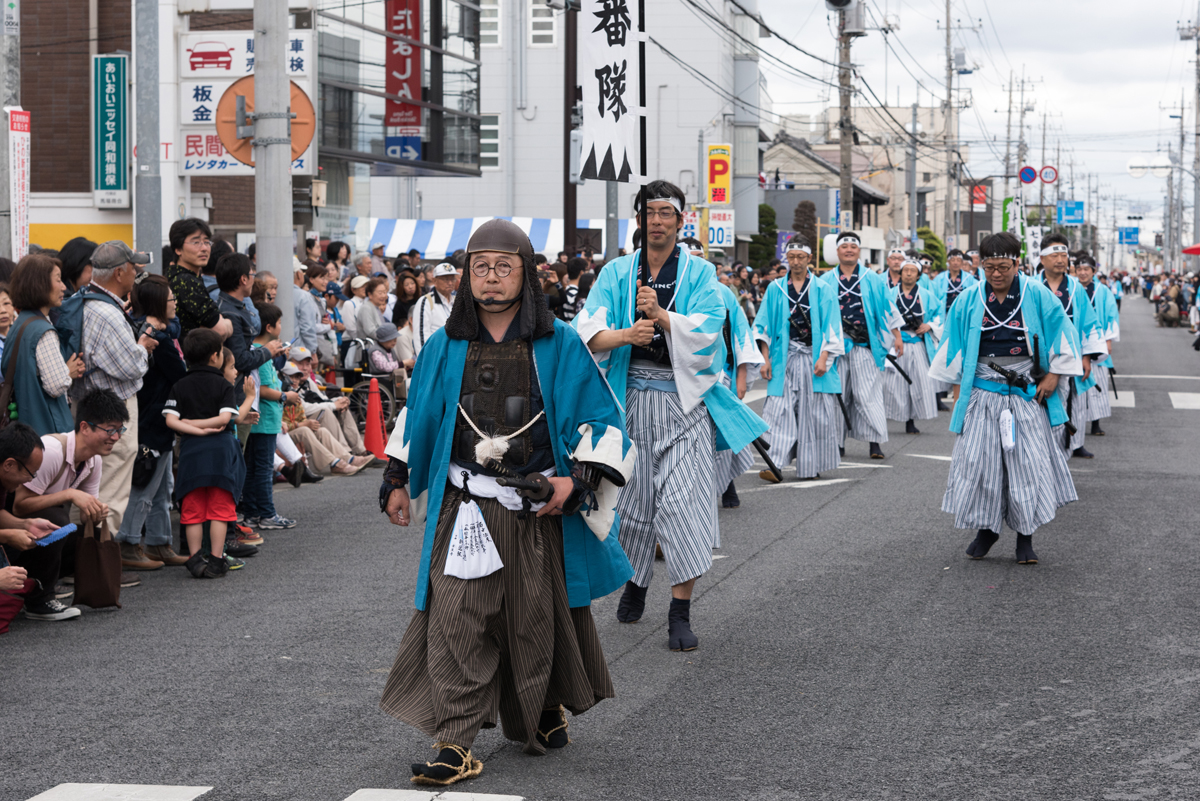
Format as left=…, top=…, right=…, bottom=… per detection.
left=91, top=55, right=130, bottom=209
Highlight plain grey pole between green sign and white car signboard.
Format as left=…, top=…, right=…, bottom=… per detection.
left=133, top=0, right=166, bottom=272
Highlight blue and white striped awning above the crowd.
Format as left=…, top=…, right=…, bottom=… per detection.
left=350, top=217, right=636, bottom=259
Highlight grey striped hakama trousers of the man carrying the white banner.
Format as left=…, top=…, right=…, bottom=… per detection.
left=617, top=367, right=724, bottom=586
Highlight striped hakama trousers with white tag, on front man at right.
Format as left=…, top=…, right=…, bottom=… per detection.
left=942, top=360, right=1079, bottom=535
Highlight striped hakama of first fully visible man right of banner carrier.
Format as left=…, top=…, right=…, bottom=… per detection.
left=762, top=341, right=846, bottom=478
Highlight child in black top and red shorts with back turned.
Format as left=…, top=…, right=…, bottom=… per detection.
left=162, top=329, right=253, bottom=578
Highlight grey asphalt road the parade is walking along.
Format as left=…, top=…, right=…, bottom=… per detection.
left=0, top=297, right=1200, bottom=801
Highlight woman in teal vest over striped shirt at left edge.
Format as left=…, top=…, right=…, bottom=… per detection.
left=0, top=253, right=84, bottom=435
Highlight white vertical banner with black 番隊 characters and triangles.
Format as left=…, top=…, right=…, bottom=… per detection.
left=576, top=0, right=646, bottom=181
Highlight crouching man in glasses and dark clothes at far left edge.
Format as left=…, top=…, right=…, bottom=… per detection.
left=0, top=422, right=78, bottom=621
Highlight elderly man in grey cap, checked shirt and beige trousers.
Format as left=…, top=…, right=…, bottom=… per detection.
left=64, top=241, right=162, bottom=546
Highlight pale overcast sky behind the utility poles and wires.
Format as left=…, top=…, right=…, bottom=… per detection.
left=758, top=0, right=1196, bottom=236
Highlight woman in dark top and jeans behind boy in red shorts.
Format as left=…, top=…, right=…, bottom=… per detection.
left=116, top=275, right=187, bottom=566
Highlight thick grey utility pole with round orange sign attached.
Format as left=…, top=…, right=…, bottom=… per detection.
left=254, top=0, right=295, bottom=342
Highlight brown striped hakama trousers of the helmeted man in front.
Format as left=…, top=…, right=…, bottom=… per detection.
left=379, top=483, right=614, bottom=754
